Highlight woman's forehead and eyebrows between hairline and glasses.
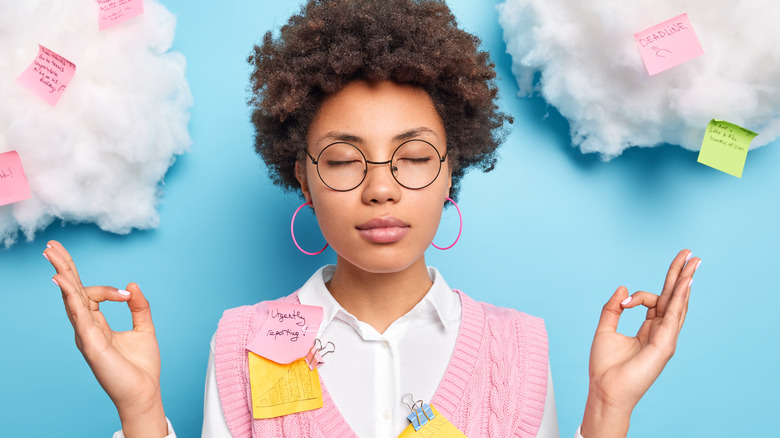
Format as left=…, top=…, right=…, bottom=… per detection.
left=308, top=81, right=445, bottom=147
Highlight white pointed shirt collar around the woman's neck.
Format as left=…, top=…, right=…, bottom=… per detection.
left=298, top=265, right=460, bottom=330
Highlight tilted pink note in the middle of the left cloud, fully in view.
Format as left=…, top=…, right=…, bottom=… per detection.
left=16, top=44, right=76, bottom=106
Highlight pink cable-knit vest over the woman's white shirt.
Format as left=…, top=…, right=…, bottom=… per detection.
left=215, top=291, right=548, bottom=438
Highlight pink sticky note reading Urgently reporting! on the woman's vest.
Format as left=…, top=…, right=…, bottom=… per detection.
left=247, top=302, right=323, bottom=364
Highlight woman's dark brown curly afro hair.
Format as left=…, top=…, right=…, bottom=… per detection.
left=248, top=0, right=512, bottom=198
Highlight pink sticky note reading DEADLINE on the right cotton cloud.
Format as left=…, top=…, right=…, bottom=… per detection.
left=634, top=14, right=704, bottom=76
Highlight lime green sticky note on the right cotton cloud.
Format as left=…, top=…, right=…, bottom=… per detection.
left=698, top=119, right=758, bottom=178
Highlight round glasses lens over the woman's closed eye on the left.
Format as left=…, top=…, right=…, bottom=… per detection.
left=317, top=143, right=366, bottom=190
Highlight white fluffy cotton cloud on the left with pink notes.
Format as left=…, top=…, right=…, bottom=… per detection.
left=0, top=0, right=192, bottom=246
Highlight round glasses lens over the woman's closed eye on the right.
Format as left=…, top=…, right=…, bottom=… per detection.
left=393, top=140, right=441, bottom=189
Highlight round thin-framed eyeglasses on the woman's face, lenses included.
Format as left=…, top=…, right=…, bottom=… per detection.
left=306, top=140, right=447, bottom=192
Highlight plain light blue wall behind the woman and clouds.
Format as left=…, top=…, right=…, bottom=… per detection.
left=0, top=0, right=780, bottom=437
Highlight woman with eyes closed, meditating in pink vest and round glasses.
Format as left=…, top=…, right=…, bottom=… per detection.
left=45, top=0, right=699, bottom=438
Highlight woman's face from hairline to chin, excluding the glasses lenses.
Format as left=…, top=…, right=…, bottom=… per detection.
left=296, top=81, right=451, bottom=273
